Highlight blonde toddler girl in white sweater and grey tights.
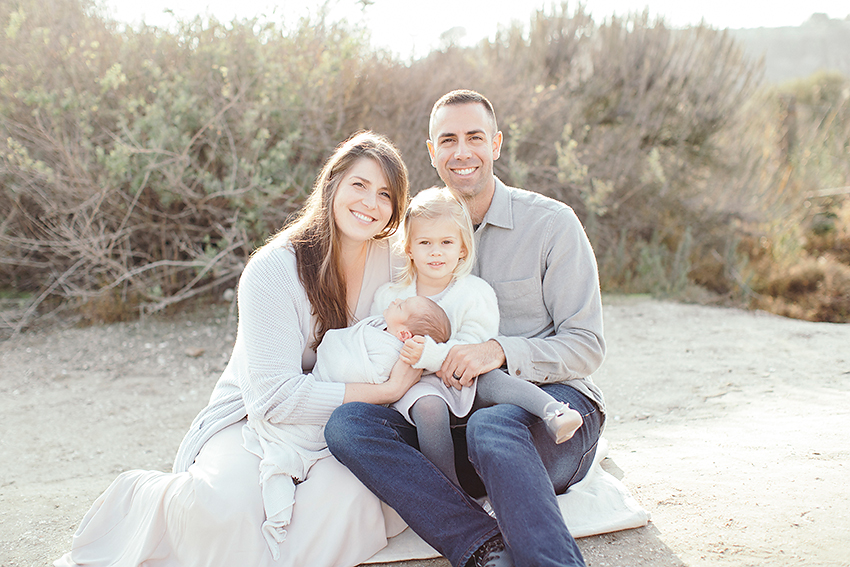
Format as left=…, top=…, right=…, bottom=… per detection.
left=372, top=187, right=582, bottom=485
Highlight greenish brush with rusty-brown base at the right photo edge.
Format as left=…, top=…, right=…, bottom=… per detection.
left=728, top=73, right=850, bottom=322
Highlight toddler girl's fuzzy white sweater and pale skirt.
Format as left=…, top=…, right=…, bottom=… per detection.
left=372, top=275, right=499, bottom=424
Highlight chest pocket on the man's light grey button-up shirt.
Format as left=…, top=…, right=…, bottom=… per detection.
left=491, top=278, right=547, bottom=337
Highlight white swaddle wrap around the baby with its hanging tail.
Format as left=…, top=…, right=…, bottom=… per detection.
left=242, top=317, right=402, bottom=560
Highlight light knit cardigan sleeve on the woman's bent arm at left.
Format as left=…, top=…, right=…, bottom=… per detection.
left=237, top=247, right=345, bottom=425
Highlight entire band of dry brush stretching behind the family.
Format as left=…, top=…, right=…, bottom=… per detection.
left=0, top=0, right=850, bottom=331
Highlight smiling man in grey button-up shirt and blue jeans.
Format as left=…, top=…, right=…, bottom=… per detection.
left=325, top=90, right=605, bottom=567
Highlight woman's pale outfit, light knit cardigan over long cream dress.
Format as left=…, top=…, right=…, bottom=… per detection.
left=54, top=242, right=405, bottom=567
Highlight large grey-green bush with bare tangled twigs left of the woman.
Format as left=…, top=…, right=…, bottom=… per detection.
left=0, top=0, right=382, bottom=331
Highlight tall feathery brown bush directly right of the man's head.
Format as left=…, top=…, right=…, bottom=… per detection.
left=438, top=4, right=766, bottom=300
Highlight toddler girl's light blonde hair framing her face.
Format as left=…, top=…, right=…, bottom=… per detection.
left=399, top=187, right=475, bottom=285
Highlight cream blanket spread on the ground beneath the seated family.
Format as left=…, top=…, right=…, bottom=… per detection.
left=366, top=439, right=650, bottom=563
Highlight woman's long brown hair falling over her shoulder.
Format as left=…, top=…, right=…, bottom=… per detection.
left=268, top=131, right=409, bottom=349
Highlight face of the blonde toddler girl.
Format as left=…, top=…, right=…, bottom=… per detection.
left=407, top=217, right=466, bottom=285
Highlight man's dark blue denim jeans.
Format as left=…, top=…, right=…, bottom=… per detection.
left=325, top=371, right=603, bottom=567
